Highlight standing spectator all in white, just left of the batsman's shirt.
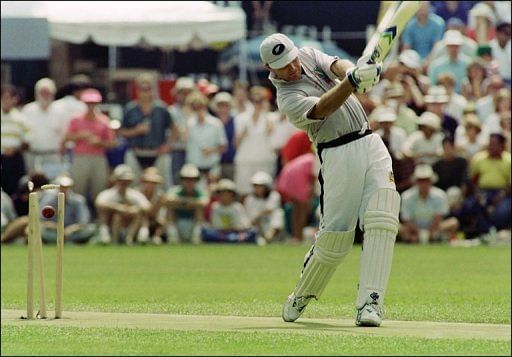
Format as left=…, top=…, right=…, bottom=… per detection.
left=235, top=86, right=277, bottom=199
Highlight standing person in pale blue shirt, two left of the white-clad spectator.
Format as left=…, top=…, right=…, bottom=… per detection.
left=186, top=92, right=228, bottom=187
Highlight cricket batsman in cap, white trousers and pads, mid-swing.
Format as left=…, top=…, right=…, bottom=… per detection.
left=260, top=33, right=400, bottom=326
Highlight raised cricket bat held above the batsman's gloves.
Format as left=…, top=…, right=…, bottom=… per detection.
left=363, top=1, right=421, bottom=64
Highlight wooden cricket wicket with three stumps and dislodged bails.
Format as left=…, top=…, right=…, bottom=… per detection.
left=26, top=183, right=65, bottom=320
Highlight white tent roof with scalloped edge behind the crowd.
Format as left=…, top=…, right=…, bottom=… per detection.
left=1, top=1, right=246, bottom=49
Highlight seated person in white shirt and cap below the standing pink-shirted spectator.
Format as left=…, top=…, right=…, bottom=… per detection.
left=95, top=164, right=151, bottom=244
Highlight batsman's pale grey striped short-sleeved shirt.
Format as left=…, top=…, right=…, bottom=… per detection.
left=268, top=47, right=369, bottom=145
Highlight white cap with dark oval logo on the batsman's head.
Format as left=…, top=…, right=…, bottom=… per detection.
left=260, top=33, right=299, bottom=69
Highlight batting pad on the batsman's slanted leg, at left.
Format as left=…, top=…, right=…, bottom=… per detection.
left=294, top=230, right=355, bottom=299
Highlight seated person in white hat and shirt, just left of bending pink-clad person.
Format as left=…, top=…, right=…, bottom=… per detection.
left=244, top=171, right=284, bottom=242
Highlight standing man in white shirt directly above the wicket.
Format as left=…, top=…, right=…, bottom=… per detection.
left=22, top=78, right=66, bottom=180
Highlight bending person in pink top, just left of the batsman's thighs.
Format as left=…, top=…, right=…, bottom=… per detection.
left=276, top=153, right=320, bottom=243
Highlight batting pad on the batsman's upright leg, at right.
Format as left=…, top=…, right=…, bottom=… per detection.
left=356, top=189, right=400, bottom=309
